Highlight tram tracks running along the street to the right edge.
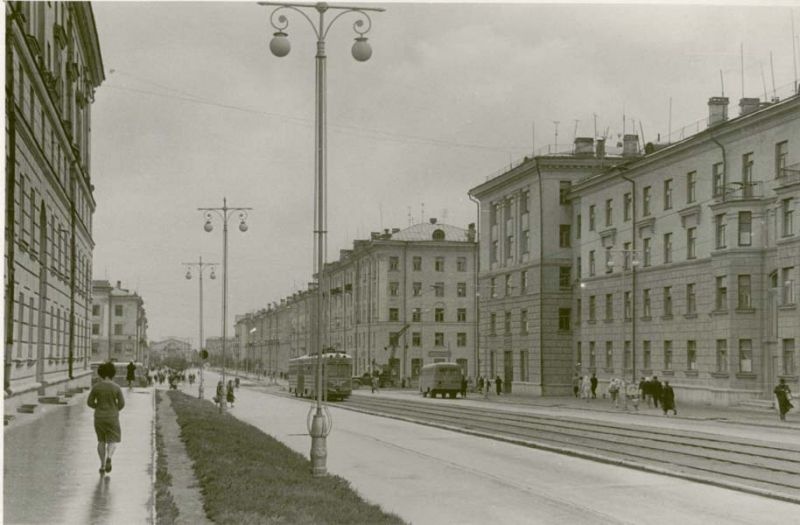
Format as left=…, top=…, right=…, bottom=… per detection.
left=335, top=396, right=800, bottom=504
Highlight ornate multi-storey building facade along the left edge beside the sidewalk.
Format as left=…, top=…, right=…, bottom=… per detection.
left=4, top=1, right=104, bottom=396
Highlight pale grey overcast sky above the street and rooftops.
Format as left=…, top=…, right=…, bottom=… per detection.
left=92, top=2, right=800, bottom=345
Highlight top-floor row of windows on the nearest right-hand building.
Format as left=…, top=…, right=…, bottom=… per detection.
left=577, top=141, right=789, bottom=231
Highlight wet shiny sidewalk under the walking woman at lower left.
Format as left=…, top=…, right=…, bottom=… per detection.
left=3, top=388, right=154, bottom=525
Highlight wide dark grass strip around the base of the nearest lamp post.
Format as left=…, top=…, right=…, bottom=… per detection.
left=169, top=391, right=403, bottom=525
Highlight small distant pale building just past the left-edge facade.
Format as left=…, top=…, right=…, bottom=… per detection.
left=92, top=280, right=149, bottom=364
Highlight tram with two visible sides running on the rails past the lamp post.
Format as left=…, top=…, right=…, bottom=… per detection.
left=289, top=352, right=353, bottom=400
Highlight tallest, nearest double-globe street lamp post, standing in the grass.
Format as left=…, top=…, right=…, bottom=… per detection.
left=259, top=2, right=384, bottom=476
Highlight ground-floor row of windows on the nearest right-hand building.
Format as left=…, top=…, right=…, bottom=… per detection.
left=577, top=339, right=795, bottom=375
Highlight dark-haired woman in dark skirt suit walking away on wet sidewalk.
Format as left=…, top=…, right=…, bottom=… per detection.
left=86, top=362, right=125, bottom=476
